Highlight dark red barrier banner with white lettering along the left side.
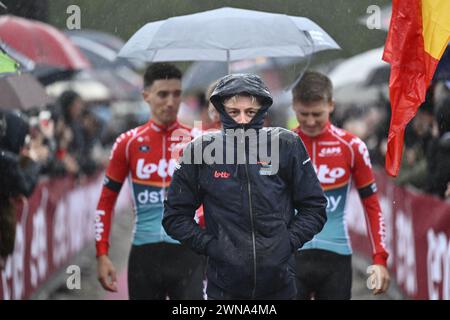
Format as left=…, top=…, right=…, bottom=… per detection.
left=0, top=175, right=130, bottom=300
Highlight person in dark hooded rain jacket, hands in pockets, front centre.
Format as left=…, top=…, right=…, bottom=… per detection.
left=163, top=74, right=327, bottom=299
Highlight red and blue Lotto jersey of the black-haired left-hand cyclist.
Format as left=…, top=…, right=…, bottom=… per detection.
left=95, top=120, right=191, bottom=256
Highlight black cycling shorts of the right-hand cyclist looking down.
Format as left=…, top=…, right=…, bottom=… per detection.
left=295, top=249, right=352, bottom=300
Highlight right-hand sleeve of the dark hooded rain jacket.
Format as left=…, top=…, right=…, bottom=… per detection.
left=288, top=137, right=327, bottom=250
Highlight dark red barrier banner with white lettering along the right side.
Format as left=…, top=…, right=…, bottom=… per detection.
left=347, top=172, right=450, bottom=300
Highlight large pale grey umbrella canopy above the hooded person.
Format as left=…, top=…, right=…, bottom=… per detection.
left=119, top=8, right=339, bottom=62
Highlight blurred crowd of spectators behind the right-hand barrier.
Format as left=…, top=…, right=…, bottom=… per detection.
left=333, top=81, right=450, bottom=198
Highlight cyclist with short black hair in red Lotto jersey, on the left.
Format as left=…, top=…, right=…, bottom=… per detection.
left=96, top=63, right=203, bottom=299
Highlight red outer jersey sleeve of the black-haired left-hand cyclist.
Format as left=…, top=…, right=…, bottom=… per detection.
left=95, top=134, right=129, bottom=257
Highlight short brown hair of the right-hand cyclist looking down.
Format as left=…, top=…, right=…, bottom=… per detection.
left=292, top=71, right=333, bottom=104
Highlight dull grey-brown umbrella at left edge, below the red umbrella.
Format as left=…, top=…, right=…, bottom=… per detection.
left=0, top=73, right=52, bottom=110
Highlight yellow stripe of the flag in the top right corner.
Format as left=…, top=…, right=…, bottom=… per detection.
left=422, top=0, right=450, bottom=60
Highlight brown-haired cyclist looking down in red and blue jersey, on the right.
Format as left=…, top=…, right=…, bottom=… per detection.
left=292, top=71, right=389, bottom=299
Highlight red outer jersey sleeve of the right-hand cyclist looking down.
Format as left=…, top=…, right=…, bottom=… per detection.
left=350, top=137, right=388, bottom=266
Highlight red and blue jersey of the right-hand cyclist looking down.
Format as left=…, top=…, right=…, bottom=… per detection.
left=294, top=123, right=388, bottom=266
